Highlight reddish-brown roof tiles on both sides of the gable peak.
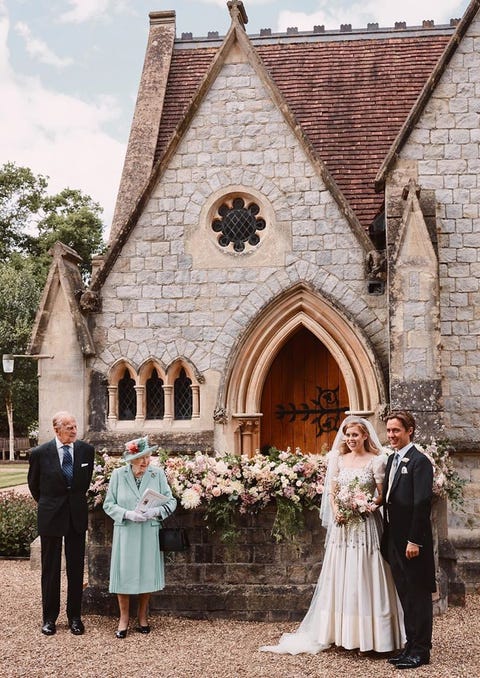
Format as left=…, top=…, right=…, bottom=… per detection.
left=156, top=29, right=453, bottom=228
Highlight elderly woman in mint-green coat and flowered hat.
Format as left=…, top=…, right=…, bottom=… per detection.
left=103, top=437, right=177, bottom=638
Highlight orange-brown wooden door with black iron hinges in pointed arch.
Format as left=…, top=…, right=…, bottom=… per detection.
left=260, top=328, right=348, bottom=454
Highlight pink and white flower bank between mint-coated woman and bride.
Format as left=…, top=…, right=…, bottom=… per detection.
left=162, top=448, right=326, bottom=543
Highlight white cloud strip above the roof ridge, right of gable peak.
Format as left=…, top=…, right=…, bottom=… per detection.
left=277, top=0, right=468, bottom=32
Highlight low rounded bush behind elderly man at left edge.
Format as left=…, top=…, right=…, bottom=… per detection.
left=0, top=490, right=37, bottom=557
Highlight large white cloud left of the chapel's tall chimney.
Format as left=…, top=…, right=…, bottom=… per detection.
left=0, top=7, right=125, bottom=230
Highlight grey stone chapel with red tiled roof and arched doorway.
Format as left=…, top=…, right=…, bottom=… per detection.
left=30, top=0, right=480, bottom=544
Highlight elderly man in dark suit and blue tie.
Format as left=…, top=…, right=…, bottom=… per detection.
left=28, top=412, right=94, bottom=636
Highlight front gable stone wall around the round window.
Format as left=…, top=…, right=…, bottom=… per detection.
left=89, top=54, right=388, bottom=449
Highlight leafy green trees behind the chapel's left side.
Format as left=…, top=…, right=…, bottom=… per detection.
left=0, top=162, right=104, bottom=436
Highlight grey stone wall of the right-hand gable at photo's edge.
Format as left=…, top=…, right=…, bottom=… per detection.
left=387, top=16, right=480, bottom=449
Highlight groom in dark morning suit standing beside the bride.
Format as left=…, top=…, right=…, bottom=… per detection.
left=381, top=411, right=436, bottom=669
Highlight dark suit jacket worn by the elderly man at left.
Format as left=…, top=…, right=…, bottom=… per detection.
left=28, top=439, right=95, bottom=537
